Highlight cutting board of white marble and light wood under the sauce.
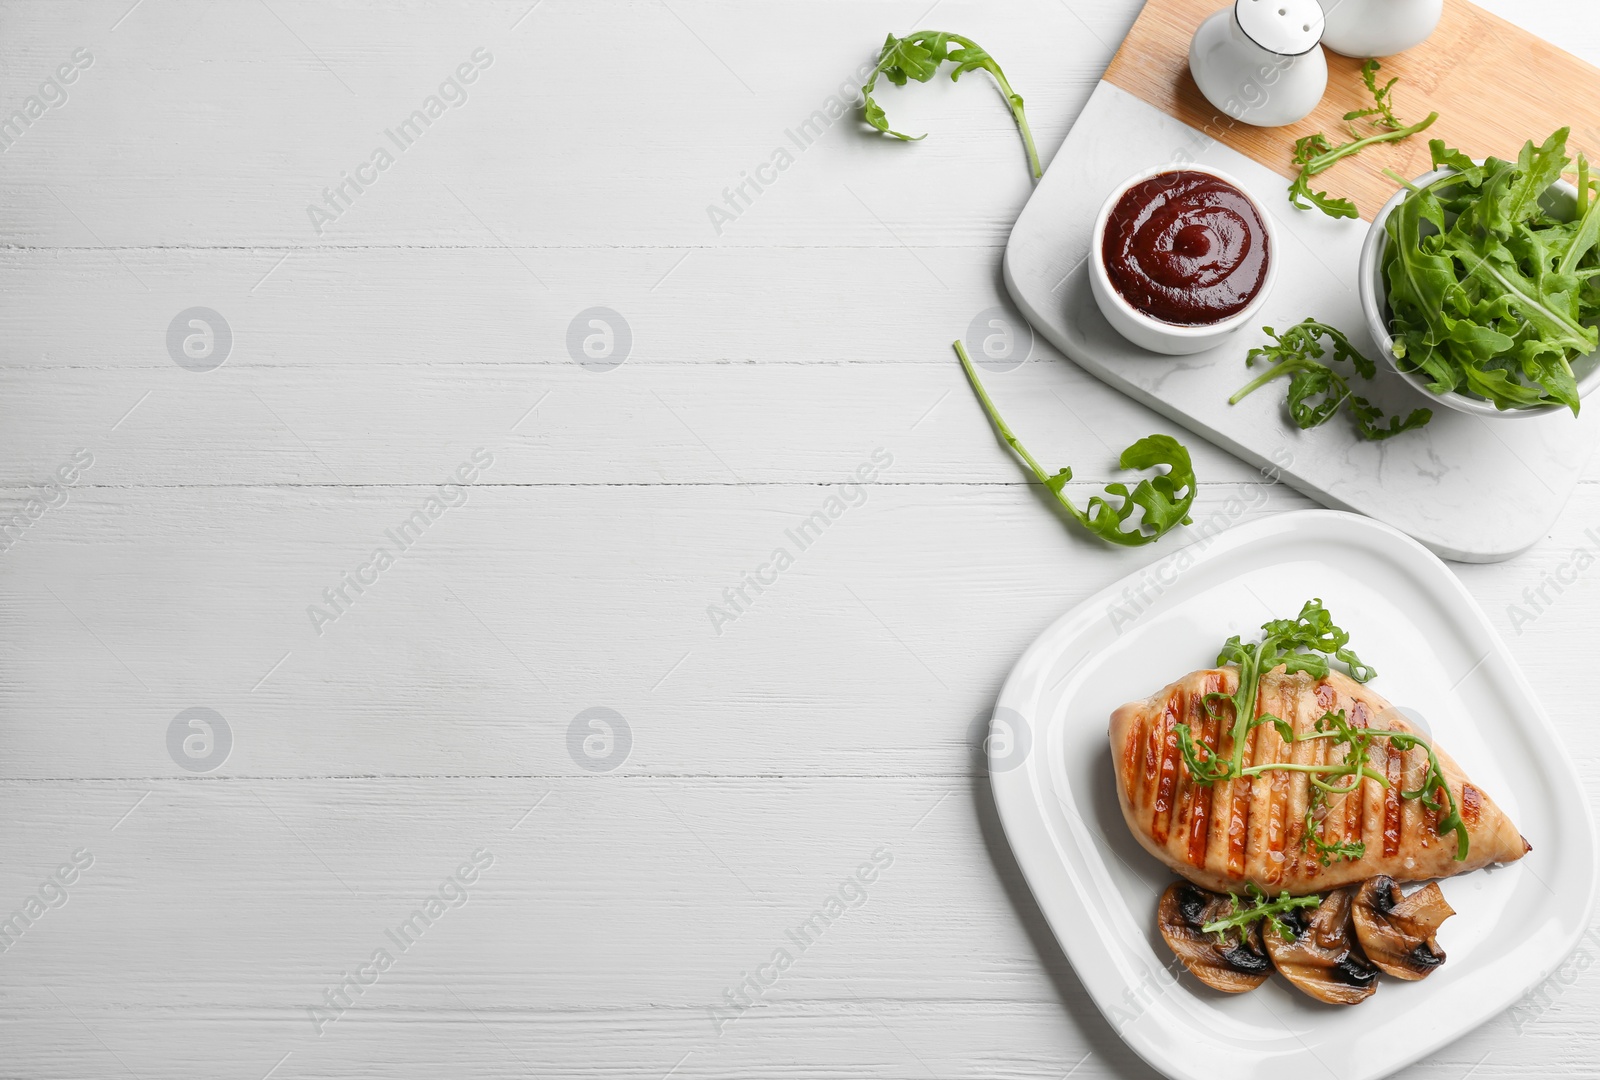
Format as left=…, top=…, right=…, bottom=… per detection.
left=989, top=0, right=1600, bottom=562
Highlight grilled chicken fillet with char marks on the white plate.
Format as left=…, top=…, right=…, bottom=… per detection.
left=1110, top=667, right=1531, bottom=896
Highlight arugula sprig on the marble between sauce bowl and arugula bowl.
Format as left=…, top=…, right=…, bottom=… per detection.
left=1227, top=318, right=1434, bottom=440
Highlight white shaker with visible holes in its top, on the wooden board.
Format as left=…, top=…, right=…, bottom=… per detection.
left=1189, top=0, right=1331, bottom=128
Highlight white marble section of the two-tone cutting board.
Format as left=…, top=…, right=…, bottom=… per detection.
left=1005, top=82, right=1597, bottom=562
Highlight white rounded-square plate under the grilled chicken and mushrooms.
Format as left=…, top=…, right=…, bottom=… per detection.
left=989, top=510, right=1597, bottom=1080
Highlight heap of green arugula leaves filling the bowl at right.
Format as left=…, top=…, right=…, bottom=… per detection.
left=1382, top=128, right=1600, bottom=416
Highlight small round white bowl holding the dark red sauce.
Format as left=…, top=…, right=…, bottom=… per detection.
left=1090, top=165, right=1282, bottom=357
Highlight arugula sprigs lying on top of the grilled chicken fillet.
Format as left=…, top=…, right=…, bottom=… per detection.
left=1173, top=598, right=1470, bottom=866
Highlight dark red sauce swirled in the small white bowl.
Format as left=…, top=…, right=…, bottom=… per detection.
left=1101, top=170, right=1272, bottom=326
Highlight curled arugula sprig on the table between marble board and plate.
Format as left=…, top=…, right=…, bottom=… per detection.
left=955, top=341, right=1198, bottom=547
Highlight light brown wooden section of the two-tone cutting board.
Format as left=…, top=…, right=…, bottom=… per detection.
left=1104, top=0, right=1600, bottom=221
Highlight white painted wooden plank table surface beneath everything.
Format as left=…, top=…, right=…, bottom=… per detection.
left=0, top=0, right=1600, bottom=1080
